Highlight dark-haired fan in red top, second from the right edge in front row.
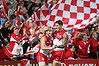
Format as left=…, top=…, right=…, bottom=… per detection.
left=78, top=34, right=89, bottom=58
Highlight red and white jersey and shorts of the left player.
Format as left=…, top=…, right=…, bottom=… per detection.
left=37, top=34, right=52, bottom=64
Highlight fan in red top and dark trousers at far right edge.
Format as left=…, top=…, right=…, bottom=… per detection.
left=89, top=32, right=99, bottom=59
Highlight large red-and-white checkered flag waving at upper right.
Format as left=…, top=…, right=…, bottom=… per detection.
left=47, top=0, right=99, bottom=29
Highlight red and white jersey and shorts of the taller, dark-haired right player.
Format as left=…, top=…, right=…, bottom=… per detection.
left=52, top=29, right=66, bottom=61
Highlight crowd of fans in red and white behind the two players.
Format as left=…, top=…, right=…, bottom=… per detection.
left=0, top=0, right=99, bottom=63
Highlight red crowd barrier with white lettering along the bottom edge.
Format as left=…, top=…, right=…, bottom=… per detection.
left=0, top=59, right=99, bottom=66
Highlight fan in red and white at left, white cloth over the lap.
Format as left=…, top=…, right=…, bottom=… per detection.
left=9, top=27, right=23, bottom=55
